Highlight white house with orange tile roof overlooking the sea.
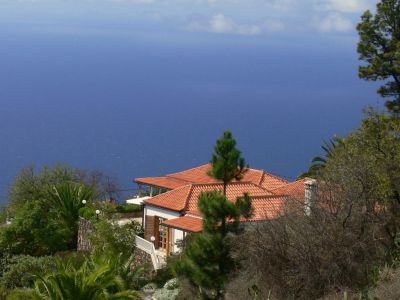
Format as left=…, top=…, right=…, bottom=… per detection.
left=135, top=164, right=312, bottom=262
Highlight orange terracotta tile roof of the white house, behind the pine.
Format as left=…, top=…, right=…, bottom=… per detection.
left=141, top=164, right=306, bottom=222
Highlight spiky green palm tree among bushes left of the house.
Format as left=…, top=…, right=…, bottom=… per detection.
left=49, top=182, right=96, bottom=249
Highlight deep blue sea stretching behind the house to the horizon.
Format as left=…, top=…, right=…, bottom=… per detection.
left=0, top=26, right=382, bottom=203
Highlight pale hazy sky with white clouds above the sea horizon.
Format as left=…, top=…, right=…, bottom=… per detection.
left=0, top=0, right=376, bottom=37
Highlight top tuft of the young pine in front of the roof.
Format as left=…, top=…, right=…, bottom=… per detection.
left=209, top=131, right=245, bottom=195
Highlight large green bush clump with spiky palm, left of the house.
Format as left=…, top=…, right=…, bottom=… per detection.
left=0, top=165, right=116, bottom=256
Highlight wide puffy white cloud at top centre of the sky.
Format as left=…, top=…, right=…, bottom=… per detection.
left=186, top=14, right=284, bottom=35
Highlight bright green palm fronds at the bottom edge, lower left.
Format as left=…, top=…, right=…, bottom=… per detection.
left=34, top=257, right=140, bottom=300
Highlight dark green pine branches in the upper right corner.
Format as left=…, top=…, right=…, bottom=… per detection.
left=357, top=0, right=400, bottom=112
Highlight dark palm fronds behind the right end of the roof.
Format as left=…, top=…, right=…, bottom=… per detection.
left=298, top=135, right=344, bottom=178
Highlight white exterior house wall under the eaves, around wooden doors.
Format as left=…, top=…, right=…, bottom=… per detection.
left=143, top=205, right=183, bottom=252
